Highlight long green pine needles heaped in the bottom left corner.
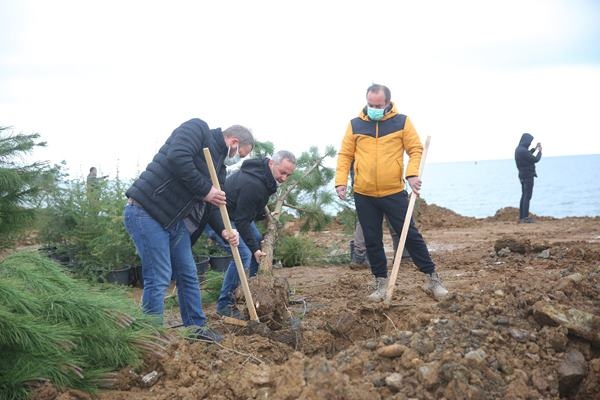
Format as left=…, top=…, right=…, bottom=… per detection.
left=0, top=252, right=166, bottom=400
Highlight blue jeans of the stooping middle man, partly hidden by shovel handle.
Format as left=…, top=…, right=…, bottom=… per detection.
left=217, top=222, right=262, bottom=310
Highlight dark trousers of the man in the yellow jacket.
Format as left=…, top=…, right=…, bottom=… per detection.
left=354, top=190, right=435, bottom=278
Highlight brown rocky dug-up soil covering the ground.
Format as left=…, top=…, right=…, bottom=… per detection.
left=40, top=205, right=600, bottom=400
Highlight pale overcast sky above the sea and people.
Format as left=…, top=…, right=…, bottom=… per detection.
left=0, top=0, right=600, bottom=177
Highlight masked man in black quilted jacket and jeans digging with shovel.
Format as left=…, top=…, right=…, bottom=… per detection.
left=124, top=119, right=254, bottom=341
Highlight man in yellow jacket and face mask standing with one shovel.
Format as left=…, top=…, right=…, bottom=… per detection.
left=335, top=84, right=448, bottom=301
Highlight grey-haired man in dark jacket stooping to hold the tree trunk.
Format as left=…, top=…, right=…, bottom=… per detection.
left=211, top=150, right=296, bottom=319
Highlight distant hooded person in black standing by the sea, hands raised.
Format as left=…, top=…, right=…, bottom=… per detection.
left=515, top=133, right=542, bottom=223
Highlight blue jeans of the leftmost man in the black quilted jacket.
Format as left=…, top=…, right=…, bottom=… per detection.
left=123, top=204, right=206, bottom=326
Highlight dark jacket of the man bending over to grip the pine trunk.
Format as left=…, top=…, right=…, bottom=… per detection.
left=225, top=158, right=277, bottom=254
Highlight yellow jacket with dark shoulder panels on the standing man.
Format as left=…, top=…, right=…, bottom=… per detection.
left=335, top=103, right=423, bottom=197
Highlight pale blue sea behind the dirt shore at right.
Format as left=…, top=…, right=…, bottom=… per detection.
left=421, top=154, right=600, bottom=218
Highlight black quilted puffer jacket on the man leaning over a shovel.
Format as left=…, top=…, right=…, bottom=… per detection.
left=126, top=118, right=227, bottom=232
